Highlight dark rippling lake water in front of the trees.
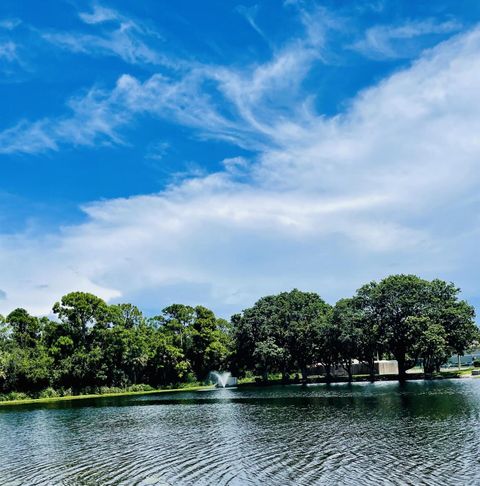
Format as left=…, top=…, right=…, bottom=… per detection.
left=0, top=379, right=480, bottom=485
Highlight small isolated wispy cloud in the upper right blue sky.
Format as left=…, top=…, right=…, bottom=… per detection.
left=350, top=19, right=462, bottom=59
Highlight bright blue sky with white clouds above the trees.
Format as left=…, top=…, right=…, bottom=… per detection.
left=0, top=0, right=480, bottom=317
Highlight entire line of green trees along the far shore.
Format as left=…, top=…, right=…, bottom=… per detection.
left=0, top=275, right=479, bottom=395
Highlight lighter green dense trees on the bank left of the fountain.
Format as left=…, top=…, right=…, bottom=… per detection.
left=0, top=292, right=232, bottom=398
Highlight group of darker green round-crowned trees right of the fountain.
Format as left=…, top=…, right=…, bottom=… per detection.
left=232, top=275, right=479, bottom=380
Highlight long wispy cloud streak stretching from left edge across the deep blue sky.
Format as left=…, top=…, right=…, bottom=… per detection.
left=0, top=4, right=323, bottom=153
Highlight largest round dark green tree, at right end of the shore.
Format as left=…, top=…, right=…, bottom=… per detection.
left=356, top=275, right=478, bottom=380
